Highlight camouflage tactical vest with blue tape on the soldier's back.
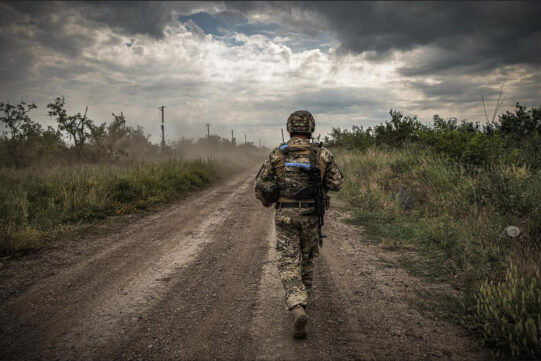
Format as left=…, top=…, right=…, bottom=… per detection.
left=273, top=143, right=327, bottom=202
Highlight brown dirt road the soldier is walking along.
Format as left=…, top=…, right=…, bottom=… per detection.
left=0, top=170, right=486, bottom=360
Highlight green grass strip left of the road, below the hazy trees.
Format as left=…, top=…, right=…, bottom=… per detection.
left=0, top=160, right=221, bottom=255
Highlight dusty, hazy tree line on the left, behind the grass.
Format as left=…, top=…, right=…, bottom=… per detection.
left=0, top=97, right=255, bottom=168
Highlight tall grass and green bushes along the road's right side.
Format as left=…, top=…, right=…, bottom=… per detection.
left=325, top=104, right=541, bottom=359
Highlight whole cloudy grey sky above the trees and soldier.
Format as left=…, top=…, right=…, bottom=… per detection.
left=0, top=1, right=541, bottom=146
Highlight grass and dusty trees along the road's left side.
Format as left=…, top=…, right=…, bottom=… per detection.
left=0, top=98, right=265, bottom=256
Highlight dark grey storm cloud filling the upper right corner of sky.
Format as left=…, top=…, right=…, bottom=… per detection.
left=221, top=1, right=541, bottom=75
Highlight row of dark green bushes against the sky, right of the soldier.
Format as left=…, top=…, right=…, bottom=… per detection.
left=324, top=103, right=541, bottom=170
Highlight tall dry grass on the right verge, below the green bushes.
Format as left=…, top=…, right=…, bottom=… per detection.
left=333, top=145, right=541, bottom=358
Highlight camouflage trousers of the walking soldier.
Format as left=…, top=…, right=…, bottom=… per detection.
left=275, top=208, right=319, bottom=309
